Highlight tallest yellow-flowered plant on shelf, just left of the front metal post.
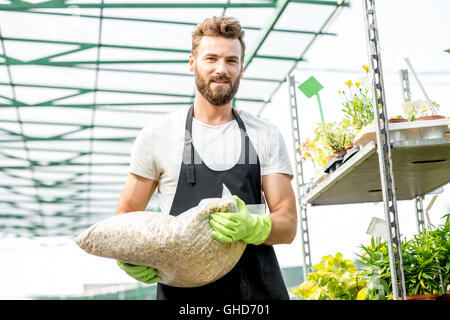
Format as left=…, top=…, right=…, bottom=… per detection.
left=339, top=66, right=374, bottom=132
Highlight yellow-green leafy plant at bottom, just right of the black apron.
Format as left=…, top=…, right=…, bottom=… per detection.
left=290, top=252, right=364, bottom=300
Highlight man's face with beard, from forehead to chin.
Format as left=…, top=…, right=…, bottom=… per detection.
left=189, top=37, right=243, bottom=106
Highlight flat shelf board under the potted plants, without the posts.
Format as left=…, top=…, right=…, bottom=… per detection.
left=302, top=134, right=450, bottom=206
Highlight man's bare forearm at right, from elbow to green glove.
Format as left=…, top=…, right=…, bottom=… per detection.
left=264, top=210, right=297, bottom=245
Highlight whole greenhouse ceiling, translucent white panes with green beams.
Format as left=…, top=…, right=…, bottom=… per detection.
left=0, top=0, right=348, bottom=237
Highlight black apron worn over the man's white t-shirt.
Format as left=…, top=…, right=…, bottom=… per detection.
left=157, top=106, right=289, bottom=301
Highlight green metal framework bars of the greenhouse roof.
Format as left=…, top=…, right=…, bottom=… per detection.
left=0, top=0, right=348, bottom=238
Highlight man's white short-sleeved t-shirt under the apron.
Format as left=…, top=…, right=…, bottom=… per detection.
left=130, top=107, right=293, bottom=213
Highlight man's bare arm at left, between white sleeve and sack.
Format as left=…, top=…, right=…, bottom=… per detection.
left=115, top=173, right=158, bottom=215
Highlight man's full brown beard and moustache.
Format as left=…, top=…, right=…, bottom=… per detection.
left=195, top=70, right=240, bottom=106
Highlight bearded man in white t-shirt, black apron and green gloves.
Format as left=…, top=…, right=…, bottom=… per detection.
left=116, top=16, right=297, bottom=301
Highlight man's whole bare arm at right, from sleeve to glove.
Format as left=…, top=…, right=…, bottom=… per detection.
left=262, top=173, right=297, bottom=245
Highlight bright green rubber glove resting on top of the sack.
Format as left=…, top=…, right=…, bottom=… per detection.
left=209, top=196, right=272, bottom=245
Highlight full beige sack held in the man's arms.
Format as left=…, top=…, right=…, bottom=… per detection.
left=75, top=198, right=246, bottom=287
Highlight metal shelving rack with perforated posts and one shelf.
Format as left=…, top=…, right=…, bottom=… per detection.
left=287, top=0, right=450, bottom=300
